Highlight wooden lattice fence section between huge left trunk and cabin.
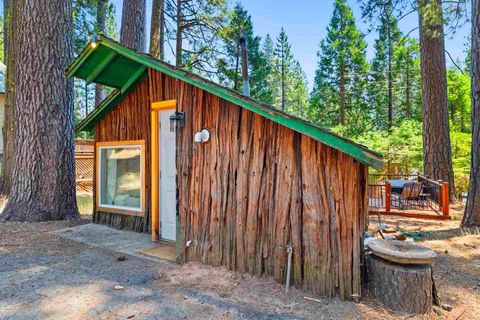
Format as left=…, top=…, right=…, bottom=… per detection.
left=75, top=139, right=95, bottom=192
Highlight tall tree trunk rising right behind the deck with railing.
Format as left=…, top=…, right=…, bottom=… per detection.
left=418, top=0, right=456, bottom=202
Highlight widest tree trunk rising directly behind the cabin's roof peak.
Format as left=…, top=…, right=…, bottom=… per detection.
left=120, top=0, right=146, bottom=52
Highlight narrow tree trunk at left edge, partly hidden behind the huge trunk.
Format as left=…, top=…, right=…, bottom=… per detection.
left=0, top=0, right=18, bottom=194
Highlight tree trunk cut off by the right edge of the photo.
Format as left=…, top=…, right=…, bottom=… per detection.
left=462, top=0, right=480, bottom=227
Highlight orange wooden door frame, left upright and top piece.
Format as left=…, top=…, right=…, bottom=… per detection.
left=150, top=100, right=177, bottom=241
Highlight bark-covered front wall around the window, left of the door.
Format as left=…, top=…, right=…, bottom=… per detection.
left=93, top=74, right=151, bottom=232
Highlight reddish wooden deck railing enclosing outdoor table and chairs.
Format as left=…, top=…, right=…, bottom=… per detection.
left=368, top=174, right=450, bottom=219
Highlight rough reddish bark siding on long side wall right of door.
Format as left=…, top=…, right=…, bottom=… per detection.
left=149, top=70, right=367, bottom=298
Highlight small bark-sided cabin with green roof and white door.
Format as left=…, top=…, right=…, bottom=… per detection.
left=67, top=37, right=382, bottom=299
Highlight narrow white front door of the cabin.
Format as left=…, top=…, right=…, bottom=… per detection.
left=158, top=110, right=177, bottom=240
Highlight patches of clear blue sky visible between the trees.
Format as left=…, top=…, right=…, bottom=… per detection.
left=112, top=0, right=470, bottom=88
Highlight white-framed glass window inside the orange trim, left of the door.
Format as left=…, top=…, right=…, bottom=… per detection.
left=98, top=145, right=143, bottom=211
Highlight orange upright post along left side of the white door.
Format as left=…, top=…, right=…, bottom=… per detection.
left=150, top=111, right=160, bottom=241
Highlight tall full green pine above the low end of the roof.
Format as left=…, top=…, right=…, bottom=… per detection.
left=309, top=0, right=369, bottom=135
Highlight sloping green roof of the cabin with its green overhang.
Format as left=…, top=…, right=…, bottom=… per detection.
left=66, top=36, right=383, bottom=168
